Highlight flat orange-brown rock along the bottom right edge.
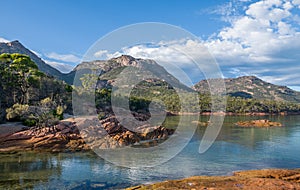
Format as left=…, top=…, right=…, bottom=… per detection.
left=128, top=169, right=300, bottom=190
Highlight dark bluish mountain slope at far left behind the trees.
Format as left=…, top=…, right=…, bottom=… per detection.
left=0, top=40, right=67, bottom=80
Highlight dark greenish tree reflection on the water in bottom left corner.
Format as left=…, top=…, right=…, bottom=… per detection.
left=0, top=153, right=62, bottom=189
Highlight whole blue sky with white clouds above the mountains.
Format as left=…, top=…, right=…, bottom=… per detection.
left=0, top=0, right=300, bottom=90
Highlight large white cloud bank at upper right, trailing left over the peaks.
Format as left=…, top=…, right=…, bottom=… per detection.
left=85, top=0, right=300, bottom=86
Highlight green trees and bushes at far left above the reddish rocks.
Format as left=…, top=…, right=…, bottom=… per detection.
left=0, top=53, right=71, bottom=124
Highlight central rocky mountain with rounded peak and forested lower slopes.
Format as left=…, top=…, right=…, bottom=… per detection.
left=73, top=55, right=197, bottom=117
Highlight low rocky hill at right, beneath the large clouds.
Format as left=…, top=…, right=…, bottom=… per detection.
left=193, top=76, right=300, bottom=103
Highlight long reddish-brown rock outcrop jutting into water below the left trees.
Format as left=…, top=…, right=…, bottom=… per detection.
left=0, top=116, right=174, bottom=152
